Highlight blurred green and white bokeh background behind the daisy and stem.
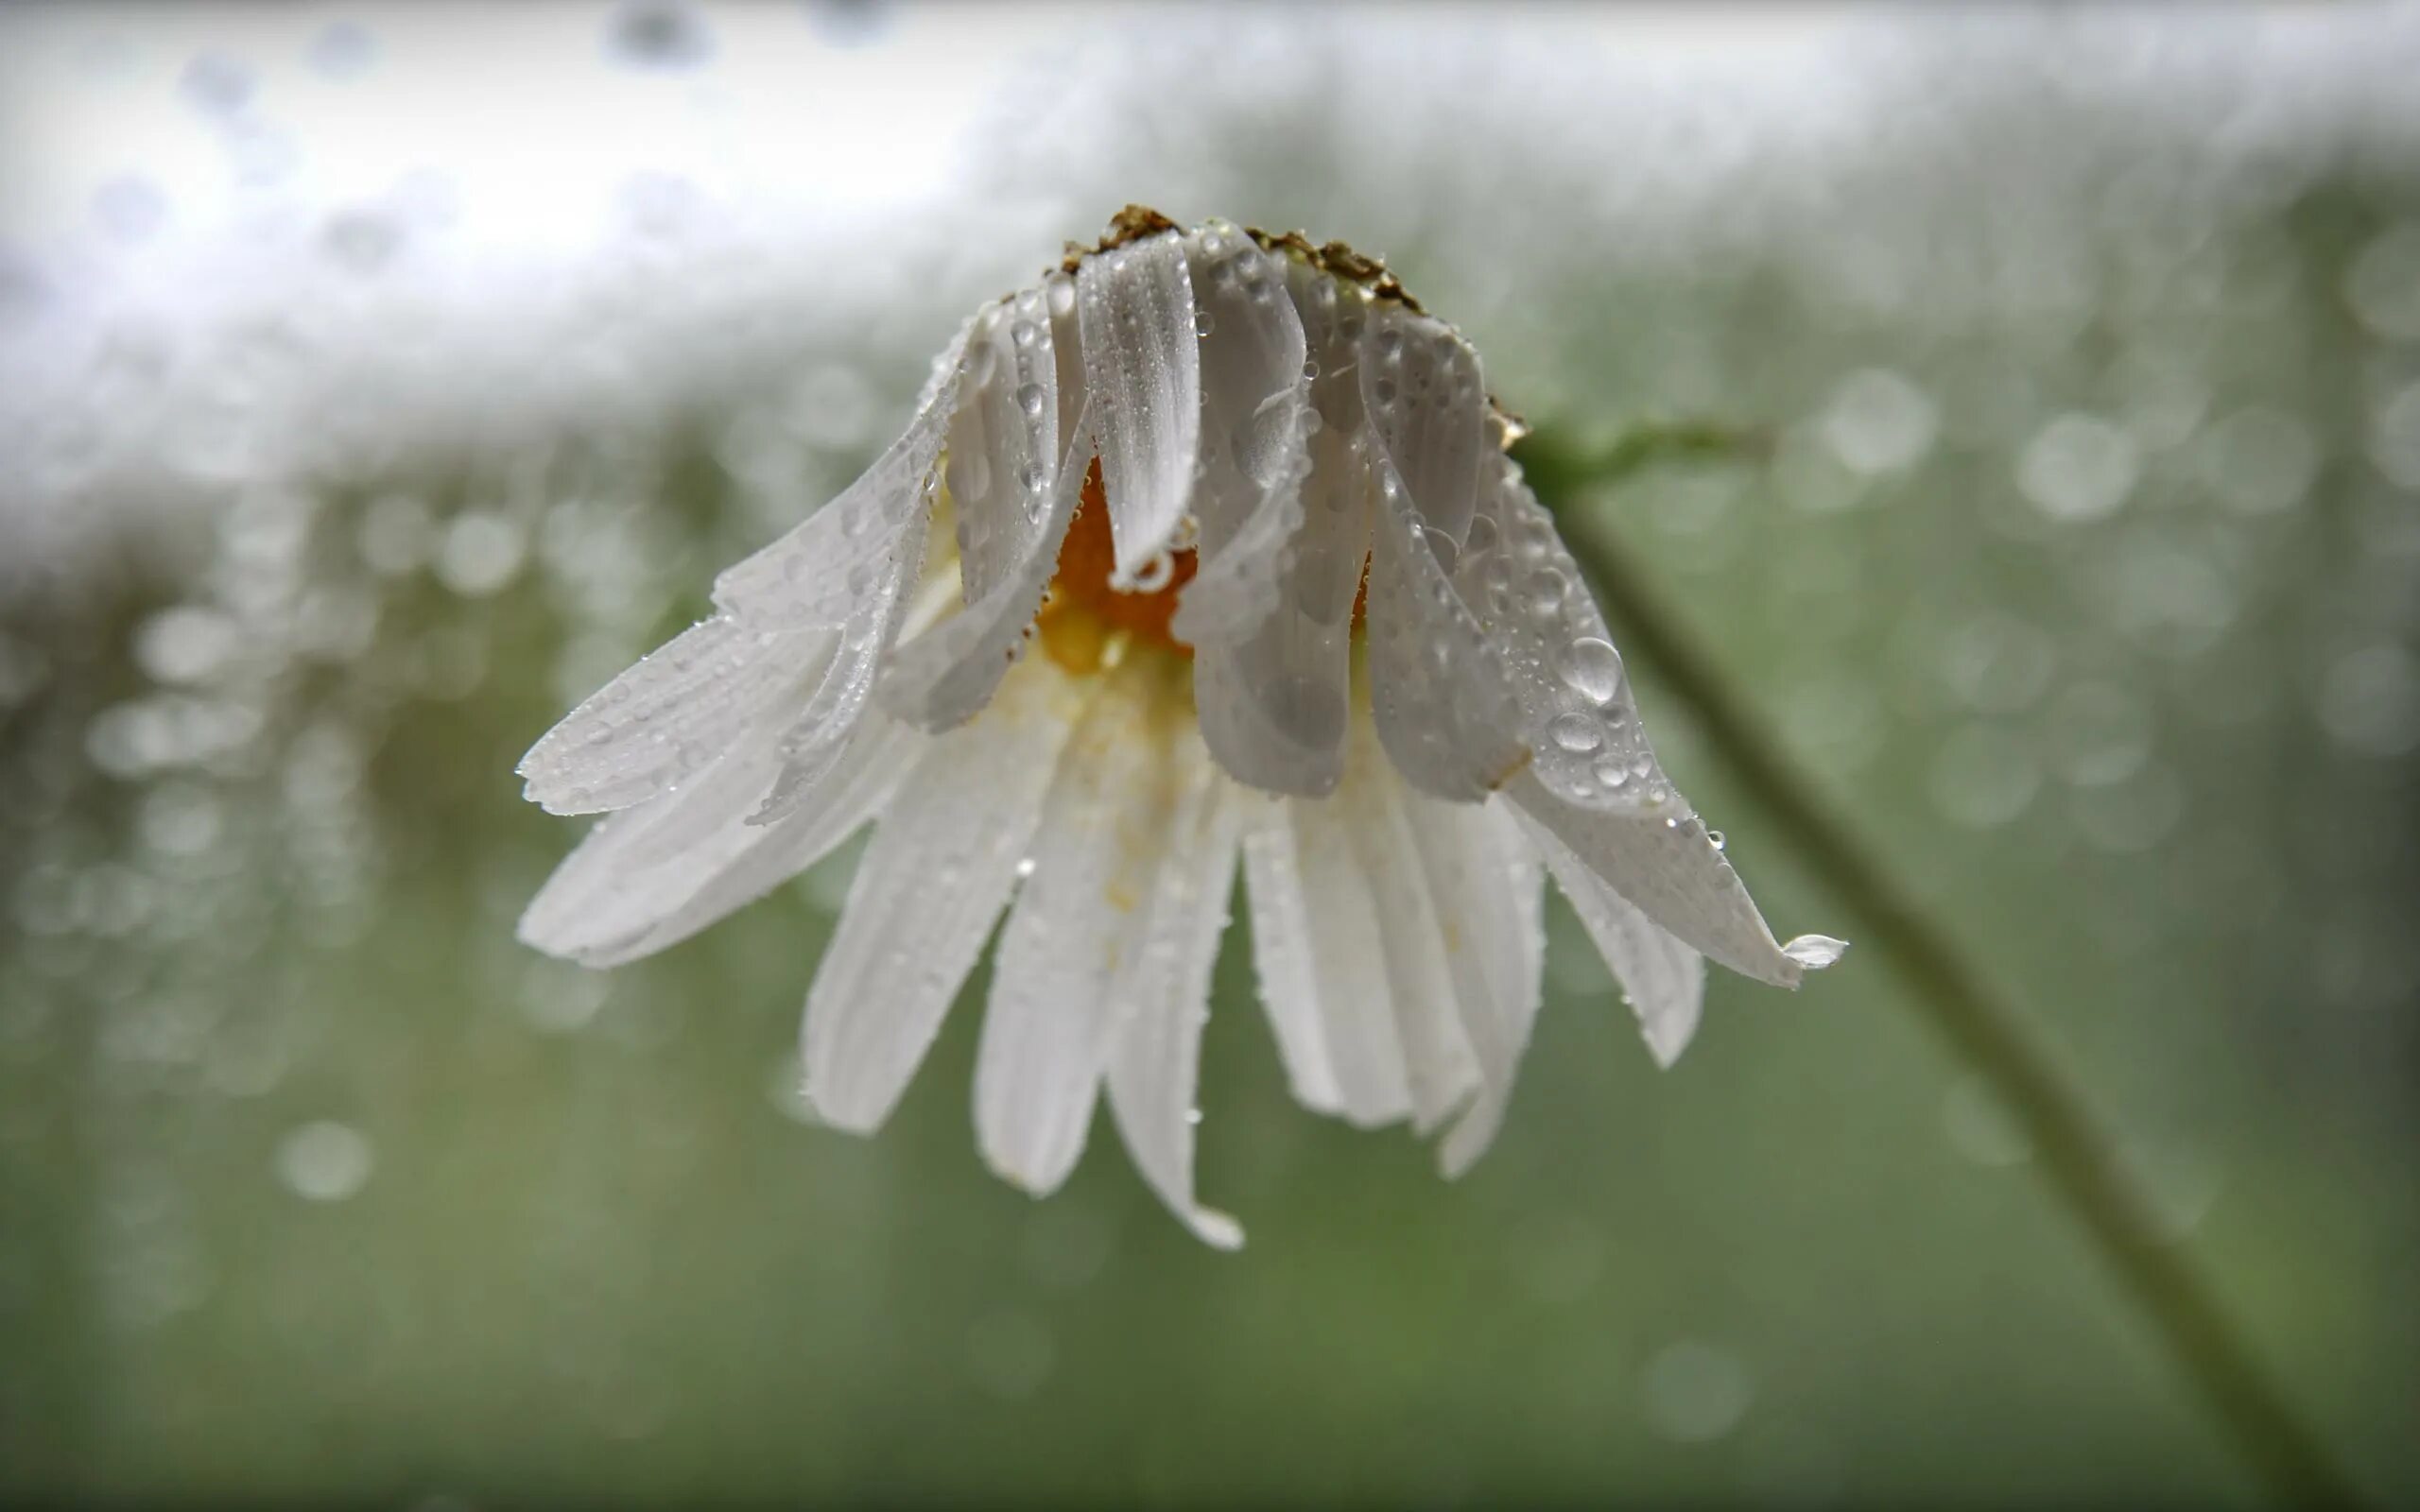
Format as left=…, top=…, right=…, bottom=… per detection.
left=0, top=5, right=2420, bottom=1507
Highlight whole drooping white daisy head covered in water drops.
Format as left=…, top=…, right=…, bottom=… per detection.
left=520, top=208, right=1841, bottom=1246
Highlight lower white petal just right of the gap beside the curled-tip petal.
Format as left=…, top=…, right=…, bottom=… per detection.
left=1244, top=799, right=1410, bottom=1127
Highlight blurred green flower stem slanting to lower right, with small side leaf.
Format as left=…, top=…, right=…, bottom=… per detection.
left=1515, top=426, right=2357, bottom=1507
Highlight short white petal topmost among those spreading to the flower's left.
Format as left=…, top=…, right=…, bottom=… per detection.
left=714, top=319, right=976, bottom=629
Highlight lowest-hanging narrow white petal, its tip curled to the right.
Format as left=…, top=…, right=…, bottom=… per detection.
left=1108, top=733, right=1244, bottom=1248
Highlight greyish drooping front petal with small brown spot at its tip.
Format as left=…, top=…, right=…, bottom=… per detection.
left=1370, top=476, right=1530, bottom=803
